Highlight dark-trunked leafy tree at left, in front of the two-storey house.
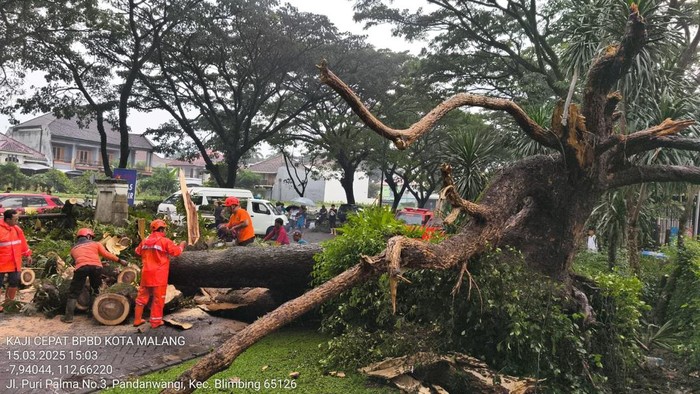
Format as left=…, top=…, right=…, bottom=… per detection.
left=11, top=0, right=199, bottom=176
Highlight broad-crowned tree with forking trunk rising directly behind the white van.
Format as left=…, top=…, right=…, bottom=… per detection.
left=141, top=0, right=337, bottom=187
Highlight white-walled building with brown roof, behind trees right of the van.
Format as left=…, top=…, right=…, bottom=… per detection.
left=247, top=154, right=374, bottom=204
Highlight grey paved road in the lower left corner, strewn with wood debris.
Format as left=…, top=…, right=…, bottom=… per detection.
left=0, top=308, right=246, bottom=394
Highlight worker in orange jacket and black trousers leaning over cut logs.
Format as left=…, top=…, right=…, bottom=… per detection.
left=61, top=228, right=127, bottom=323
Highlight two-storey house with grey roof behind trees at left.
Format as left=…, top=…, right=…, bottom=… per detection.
left=7, top=114, right=153, bottom=175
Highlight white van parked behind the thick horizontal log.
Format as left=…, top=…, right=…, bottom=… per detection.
left=158, top=187, right=288, bottom=235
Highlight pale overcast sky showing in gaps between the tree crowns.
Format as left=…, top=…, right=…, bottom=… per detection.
left=0, top=0, right=424, bottom=134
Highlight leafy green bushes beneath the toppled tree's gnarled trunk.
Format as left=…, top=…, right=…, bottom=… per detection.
left=314, top=209, right=646, bottom=392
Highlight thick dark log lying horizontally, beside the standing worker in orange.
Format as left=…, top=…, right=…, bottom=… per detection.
left=169, top=244, right=321, bottom=301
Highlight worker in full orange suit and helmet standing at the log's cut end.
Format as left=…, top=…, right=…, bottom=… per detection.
left=134, top=219, right=185, bottom=328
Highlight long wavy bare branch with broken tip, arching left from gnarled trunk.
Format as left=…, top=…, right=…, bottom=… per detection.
left=318, top=61, right=559, bottom=150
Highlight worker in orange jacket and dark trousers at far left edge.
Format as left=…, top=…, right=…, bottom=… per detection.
left=0, top=209, right=32, bottom=312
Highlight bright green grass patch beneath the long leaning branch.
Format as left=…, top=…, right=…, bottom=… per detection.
left=103, top=327, right=399, bottom=394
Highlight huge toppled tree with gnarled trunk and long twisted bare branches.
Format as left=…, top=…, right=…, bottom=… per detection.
left=165, top=4, right=700, bottom=392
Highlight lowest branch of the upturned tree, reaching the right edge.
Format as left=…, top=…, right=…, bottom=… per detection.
left=607, top=166, right=700, bottom=189
